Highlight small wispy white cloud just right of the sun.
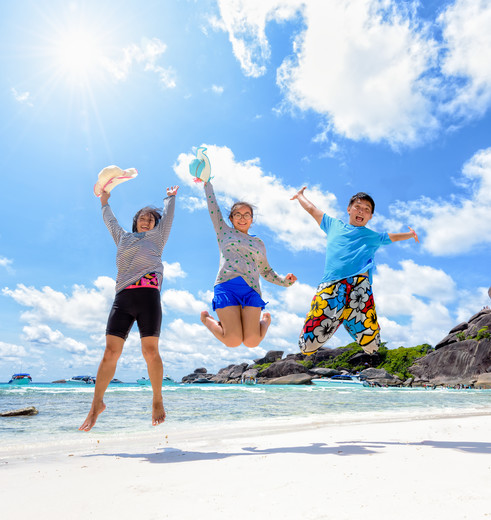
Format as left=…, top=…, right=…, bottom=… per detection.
left=101, top=38, right=176, bottom=88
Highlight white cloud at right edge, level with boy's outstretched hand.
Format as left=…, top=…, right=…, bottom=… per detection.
left=390, top=148, right=491, bottom=256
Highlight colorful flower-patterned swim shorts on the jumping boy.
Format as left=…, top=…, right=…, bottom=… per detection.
left=298, top=275, right=380, bottom=355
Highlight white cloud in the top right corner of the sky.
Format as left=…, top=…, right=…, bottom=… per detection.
left=438, top=0, right=491, bottom=118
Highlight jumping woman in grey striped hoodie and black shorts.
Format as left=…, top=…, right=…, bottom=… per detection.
left=79, top=186, right=179, bottom=432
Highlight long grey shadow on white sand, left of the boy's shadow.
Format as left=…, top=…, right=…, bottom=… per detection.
left=84, top=443, right=376, bottom=464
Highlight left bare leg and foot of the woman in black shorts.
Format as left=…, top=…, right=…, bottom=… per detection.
left=79, top=335, right=125, bottom=432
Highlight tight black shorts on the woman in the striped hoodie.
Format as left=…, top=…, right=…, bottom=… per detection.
left=106, top=287, right=162, bottom=339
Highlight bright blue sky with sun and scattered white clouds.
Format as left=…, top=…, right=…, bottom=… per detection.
left=0, top=0, right=491, bottom=381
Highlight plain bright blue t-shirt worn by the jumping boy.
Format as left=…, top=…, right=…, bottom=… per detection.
left=321, top=214, right=392, bottom=283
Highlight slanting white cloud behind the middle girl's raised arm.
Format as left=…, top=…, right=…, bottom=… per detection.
left=174, top=145, right=338, bottom=251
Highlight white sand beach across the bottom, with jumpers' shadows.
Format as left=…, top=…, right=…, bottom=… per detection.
left=0, top=414, right=491, bottom=520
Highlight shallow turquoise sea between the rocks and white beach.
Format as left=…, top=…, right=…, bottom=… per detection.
left=0, top=383, right=491, bottom=448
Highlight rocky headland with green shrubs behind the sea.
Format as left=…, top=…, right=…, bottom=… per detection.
left=182, top=307, right=491, bottom=389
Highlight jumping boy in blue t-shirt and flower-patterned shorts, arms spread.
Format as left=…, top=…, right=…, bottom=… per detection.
left=292, top=186, right=419, bottom=356
